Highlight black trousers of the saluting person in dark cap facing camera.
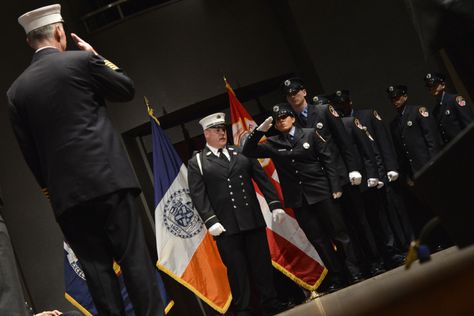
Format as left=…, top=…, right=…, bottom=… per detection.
left=294, top=199, right=360, bottom=282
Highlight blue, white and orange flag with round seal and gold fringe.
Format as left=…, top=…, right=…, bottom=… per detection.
left=145, top=104, right=232, bottom=313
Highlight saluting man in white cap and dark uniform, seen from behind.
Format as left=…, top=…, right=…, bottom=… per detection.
left=7, top=4, right=164, bottom=315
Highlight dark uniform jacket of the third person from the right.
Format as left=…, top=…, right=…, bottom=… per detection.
left=352, top=109, right=399, bottom=180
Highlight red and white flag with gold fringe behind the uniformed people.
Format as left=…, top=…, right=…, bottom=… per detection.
left=224, top=78, right=327, bottom=291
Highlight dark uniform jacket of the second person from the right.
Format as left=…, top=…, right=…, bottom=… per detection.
left=390, top=105, right=441, bottom=177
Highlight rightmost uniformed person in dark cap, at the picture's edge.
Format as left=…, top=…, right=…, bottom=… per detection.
left=425, top=73, right=474, bottom=144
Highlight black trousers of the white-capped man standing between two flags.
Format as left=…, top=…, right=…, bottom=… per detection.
left=214, top=227, right=277, bottom=316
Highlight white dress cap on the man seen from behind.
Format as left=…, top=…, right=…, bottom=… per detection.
left=18, top=4, right=64, bottom=34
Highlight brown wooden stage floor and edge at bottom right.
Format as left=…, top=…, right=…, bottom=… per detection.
left=279, top=246, right=474, bottom=316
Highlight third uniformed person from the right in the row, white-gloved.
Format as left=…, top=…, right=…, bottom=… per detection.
left=331, top=90, right=413, bottom=254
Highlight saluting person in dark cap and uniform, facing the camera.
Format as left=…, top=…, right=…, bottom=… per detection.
left=243, top=103, right=363, bottom=291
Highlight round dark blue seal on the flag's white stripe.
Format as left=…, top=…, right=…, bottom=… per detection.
left=163, top=189, right=204, bottom=239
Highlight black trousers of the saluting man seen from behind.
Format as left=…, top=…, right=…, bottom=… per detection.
left=58, top=190, right=164, bottom=316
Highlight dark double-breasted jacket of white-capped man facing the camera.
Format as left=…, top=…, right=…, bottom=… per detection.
left=188, top=146, right=281, bottom=235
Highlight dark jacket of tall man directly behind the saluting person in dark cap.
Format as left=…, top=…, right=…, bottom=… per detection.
left=295, top=104, right=361, bottom=185
